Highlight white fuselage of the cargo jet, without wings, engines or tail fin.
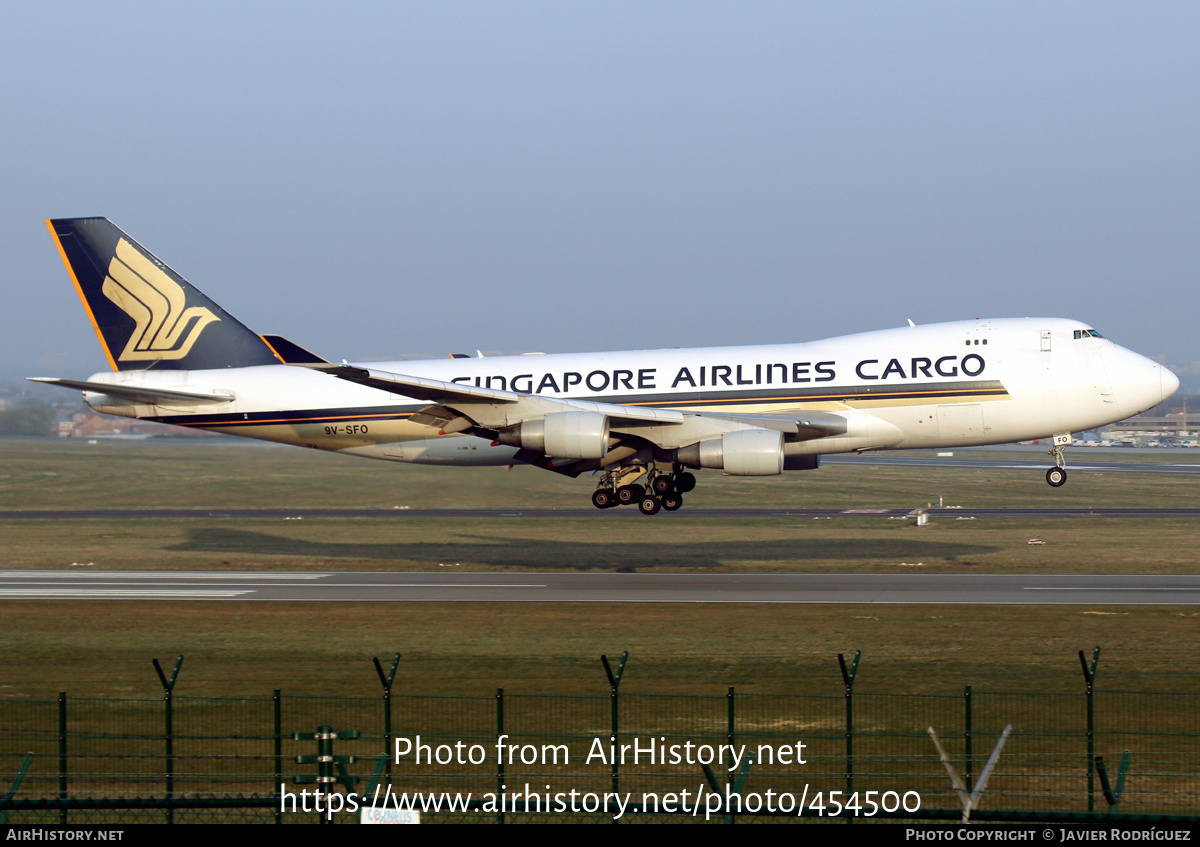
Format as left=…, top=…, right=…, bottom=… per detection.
left=85, top=318, right=1178, bottom=464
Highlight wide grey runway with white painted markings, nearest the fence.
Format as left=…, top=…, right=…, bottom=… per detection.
left=0, top=570, right=1200, bottom=606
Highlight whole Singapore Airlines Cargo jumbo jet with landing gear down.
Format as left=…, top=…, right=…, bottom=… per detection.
left=35, top=217, right=1180, bottom=515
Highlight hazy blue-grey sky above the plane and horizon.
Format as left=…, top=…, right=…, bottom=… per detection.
left=0, top=0, right=1200, bottom=377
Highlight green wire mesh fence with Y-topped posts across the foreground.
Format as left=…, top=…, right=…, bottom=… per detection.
left=0, top=659, right=1200, bottom=823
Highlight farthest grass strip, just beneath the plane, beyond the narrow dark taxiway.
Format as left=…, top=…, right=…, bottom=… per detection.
left=7, top=439, right=1200, bottom=508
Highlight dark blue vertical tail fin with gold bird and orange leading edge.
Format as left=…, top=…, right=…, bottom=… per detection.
left=46, top=217, right=280, bottom=371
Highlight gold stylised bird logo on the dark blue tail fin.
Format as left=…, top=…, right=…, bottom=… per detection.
left=102, top=239, right=221, bottom=361
